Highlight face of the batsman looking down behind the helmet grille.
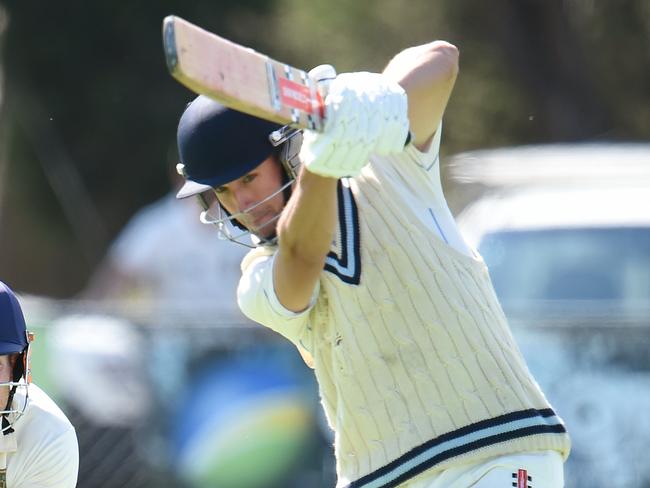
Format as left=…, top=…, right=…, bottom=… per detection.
left=215, top=156, right=284, bottom=238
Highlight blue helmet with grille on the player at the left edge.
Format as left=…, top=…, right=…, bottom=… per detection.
left=0, top=281, right=34, bottom=434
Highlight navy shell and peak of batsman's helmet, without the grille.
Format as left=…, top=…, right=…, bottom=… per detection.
left=176, top=95, right=281, bottom=198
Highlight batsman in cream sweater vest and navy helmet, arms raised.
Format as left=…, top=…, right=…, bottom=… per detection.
left=171, top=41, right=570, bottom=488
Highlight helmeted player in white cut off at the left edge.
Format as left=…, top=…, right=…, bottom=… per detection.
left=0, top=282, right=79, bottom=488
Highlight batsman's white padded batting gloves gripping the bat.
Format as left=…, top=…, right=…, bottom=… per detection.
left=300, top=72, right=409, bottom=178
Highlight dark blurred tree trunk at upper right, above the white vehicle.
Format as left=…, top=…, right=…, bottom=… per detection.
left=476, top=0, right=611, bottom=140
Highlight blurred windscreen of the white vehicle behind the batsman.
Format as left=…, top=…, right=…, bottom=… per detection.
left=478, top=227, right=650, bottom=305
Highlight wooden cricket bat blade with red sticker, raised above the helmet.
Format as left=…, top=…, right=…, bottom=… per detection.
left=163, top=15, right=323, bottom=130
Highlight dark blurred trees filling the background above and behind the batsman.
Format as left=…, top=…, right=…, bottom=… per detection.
left=0, top=0, right=650, bottom=297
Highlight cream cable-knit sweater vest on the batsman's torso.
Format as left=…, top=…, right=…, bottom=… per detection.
left=296, top=148, right=569, bottom=486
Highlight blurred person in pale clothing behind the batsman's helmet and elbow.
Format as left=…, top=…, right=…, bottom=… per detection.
left=85, top=168, right=247, bottom=324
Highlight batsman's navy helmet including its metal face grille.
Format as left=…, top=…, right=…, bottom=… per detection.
left=176, top=95, right=302, bottom=245
